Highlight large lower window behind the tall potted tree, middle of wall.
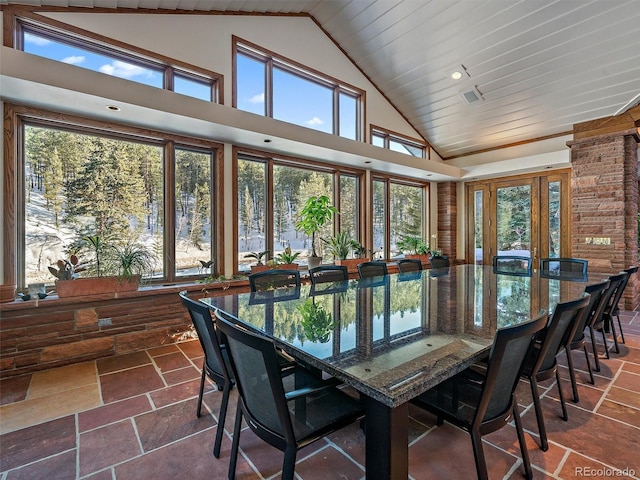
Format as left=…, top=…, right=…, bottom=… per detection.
left=236, top=154, right=359, bottom=272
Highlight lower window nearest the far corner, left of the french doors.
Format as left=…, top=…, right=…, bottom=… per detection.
left=373, top=178, right=427, bottom=258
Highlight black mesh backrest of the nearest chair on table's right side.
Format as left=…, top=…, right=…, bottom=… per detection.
left=474, top=312, right=548, bottom=424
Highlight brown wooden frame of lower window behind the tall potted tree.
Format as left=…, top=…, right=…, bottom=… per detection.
left=232, top=146, right=366, bottom=275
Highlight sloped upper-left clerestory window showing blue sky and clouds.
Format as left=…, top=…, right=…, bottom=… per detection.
left=18, top=21, right=221, bottom=102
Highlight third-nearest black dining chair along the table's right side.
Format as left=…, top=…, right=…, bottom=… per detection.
left=565, top=280, right=609, bottom=403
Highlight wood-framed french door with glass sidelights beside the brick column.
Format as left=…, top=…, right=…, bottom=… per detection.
left=466, top=170, right=571, bottom=268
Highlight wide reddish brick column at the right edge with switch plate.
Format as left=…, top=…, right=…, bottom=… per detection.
left=567, top=124, right=640, bottom=310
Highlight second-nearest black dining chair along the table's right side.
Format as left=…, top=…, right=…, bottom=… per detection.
left=522, top=293, right=590, bottom=452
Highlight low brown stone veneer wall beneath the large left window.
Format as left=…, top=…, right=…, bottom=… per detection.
left=0, top=281, right=248, bottom=378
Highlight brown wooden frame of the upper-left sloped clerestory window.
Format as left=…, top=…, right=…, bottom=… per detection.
left=10, top=12, right=224, bottom=104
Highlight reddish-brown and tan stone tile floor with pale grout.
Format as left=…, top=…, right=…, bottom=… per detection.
left=0, top=312, right=640, bottom=480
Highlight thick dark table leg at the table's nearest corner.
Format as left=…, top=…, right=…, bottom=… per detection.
left=363, top=395, right=409, bottom=480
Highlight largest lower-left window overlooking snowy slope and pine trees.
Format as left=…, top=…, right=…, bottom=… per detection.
left=10, top=108, right=218, bottom=287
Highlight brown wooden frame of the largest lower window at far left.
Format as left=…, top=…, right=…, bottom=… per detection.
left=3, top=103, right=224, bottom=289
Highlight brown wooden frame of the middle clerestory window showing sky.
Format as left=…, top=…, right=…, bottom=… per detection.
left=231, top=35, right=366, bottom=142
